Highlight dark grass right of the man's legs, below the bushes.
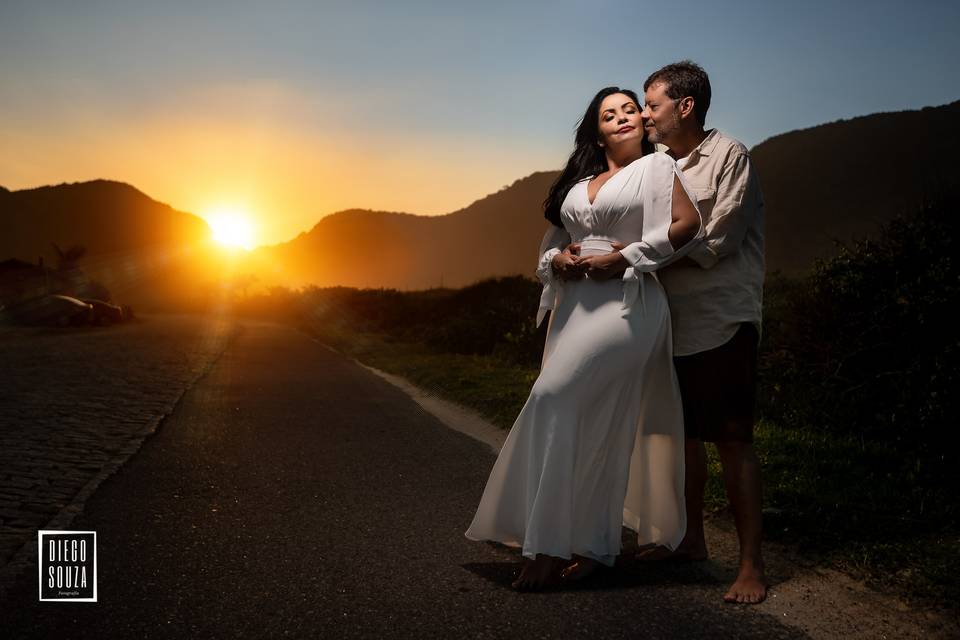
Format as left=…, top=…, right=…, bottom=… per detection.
left=744, top=421, right=960, bottom=610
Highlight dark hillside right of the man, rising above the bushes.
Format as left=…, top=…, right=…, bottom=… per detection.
left=750, top=101, right=960, bottom=274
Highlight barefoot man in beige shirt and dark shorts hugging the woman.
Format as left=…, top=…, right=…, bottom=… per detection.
left=552, top=61, right=766, bottom=603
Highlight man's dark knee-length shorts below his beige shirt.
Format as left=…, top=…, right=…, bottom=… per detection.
left=673, top=322, right=758, bottom=442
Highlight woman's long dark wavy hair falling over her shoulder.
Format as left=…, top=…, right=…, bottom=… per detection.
left=543, top=87, right=656, bottom=227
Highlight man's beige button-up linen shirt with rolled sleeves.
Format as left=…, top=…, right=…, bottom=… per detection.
left=659, top=129, right=764, bottom=356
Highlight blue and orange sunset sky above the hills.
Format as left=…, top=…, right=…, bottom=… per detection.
left=0, top=0, right=960, bottom=239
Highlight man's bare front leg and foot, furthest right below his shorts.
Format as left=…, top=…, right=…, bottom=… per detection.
left=716, top=442, right=767, bottom=604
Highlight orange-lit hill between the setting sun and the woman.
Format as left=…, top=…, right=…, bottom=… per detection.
left=251, top=172, right=556, bottom=289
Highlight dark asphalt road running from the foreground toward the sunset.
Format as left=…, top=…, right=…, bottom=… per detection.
left=0, top=323, right=800, bottom=639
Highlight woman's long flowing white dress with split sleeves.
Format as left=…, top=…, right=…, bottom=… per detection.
left=465, top=153, right=703, bottom=566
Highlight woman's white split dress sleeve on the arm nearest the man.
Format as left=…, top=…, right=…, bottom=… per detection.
left=620, top=153, right=704, bottom=272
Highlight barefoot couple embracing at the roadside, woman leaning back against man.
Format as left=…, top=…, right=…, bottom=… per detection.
left=466, top=61, right=766, bottom=603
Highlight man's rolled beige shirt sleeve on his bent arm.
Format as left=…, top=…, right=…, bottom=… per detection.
left=690, top=151, right=760, bottom=269
